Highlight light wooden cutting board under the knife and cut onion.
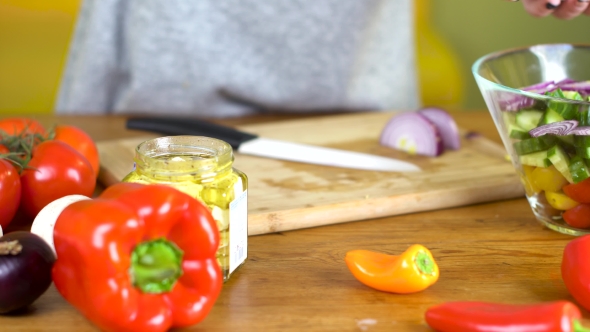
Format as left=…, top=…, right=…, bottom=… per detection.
left=97, top=112, right=524, bottom=235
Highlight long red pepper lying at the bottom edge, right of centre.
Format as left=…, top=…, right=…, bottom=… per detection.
left=425, top=301, right=590, bottom=332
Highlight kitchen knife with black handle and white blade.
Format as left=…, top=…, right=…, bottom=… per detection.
left=127, top=116, right=421, bottom=172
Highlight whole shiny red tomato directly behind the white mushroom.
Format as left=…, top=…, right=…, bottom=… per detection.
left=21, top=140, right=96, bottom=218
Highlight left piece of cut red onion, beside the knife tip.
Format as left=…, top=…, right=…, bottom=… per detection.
left=379, top=112, right=443, bottom=157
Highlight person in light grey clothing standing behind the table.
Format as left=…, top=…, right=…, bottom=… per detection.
left=55, top=0, right=588, bottom=117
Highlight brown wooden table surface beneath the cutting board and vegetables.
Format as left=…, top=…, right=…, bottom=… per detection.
left=0, top=111, right=590, bottom=332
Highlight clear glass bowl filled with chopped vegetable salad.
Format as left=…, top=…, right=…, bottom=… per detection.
left=472, top=44, right=590, bottom=236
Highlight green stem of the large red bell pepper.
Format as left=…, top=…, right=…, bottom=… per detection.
left=129, top=239, right=183, bottom=294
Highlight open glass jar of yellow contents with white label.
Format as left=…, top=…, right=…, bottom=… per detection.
left=123, top=136, right=248, bottom=281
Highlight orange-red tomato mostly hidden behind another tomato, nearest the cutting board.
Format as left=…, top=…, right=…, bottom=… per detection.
left=54, top=125, right=100, bottom=177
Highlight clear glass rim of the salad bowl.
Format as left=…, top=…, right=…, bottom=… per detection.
left=471, top=43, right=590, bottom=105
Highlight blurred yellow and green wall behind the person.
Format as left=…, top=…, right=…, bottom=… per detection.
left=0, top=0, right=590, bottom=114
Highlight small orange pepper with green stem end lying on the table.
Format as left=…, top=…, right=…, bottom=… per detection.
left=345, top=244, right=439, bottom=294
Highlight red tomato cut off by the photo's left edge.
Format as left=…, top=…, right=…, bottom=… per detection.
left=0, top=159, right=21, bottom=228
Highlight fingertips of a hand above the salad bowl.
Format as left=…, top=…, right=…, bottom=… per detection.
left=515, top=0, right=590, bottom=20
